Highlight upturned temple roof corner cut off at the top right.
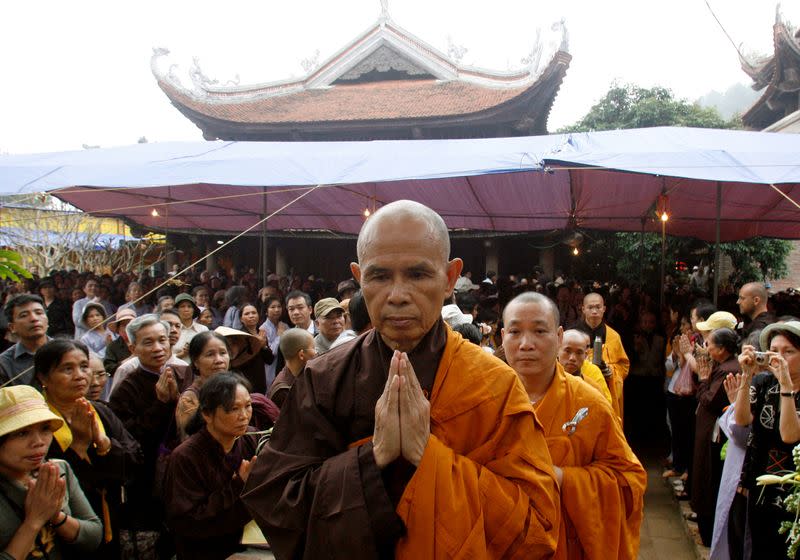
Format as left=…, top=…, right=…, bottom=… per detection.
left=739, top=10, right=800, bottom=130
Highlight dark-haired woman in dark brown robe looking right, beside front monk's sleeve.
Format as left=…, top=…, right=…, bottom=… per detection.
left=164, top=373, right=256, bottom=560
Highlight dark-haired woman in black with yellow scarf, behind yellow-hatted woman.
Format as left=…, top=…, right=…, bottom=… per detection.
left=34, top=339, right=142, bottom=558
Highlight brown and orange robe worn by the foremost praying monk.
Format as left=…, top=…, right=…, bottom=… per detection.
left=243, top=321, right=558, bottom=559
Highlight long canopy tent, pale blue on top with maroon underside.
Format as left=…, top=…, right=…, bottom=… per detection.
left=0, top=127, right=800, bottom=298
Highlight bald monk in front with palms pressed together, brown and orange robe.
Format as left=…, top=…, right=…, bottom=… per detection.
left=243, top=201, right=559, bottom=560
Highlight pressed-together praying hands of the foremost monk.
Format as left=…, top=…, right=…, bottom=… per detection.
left=372, top=351, right=431, bottom=469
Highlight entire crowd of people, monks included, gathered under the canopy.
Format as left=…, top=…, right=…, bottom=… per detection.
left=0, top=201, right=800, bottom=559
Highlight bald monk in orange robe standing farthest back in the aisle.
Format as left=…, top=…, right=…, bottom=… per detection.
left=576, top=292, right=631, bottom=421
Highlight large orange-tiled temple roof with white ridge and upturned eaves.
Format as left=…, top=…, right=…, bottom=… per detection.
left=151, top=14, right=571, bottom=140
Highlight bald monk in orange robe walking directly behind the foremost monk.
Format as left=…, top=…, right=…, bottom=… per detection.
left=502, top=292, right=647, bottom=560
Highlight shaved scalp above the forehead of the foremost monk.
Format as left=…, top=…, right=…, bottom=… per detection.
left=356, top=200, right=450, bottom=262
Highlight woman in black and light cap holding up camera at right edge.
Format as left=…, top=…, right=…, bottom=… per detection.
left=734, top=321, right=800, bottom=558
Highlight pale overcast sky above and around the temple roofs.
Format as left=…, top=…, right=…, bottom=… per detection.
left=0, top=0, right=800, bottom=153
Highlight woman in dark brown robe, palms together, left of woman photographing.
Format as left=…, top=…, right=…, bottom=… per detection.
left=691, top=328, right=739, bottom=546
